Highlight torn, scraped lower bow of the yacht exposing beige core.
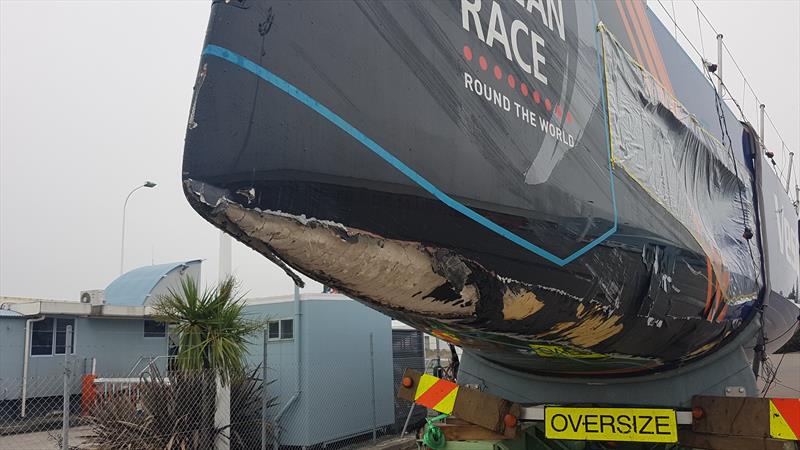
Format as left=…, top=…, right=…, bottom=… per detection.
left=186, top=180, right=731, bottom=376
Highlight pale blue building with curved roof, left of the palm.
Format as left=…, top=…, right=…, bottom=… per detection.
left=0, top=260, right=201, bottom=416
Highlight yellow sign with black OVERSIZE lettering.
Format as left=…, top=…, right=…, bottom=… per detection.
left=544, top=407, right=678, bottom=443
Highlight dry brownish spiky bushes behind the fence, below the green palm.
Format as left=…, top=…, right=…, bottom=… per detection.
left=85, top=366, right=278, bottom=450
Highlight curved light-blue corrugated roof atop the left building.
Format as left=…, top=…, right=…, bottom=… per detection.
left=105, top=259, right=200, bottom=306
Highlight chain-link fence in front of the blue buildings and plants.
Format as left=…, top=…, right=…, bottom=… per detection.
left=0, top=327, right=426, bottom=450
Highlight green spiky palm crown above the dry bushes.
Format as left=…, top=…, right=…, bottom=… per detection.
left=153, top=277, right=266, bottom=384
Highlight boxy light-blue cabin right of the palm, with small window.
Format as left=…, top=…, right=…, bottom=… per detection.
left=245, top=292, right=395, bottom=447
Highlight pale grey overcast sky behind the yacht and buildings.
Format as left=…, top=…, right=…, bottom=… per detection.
left=0, top=0, right=800, bottom=299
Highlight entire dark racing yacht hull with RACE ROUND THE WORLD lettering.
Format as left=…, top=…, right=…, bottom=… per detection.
left=183, top=0, right=798, bottom=377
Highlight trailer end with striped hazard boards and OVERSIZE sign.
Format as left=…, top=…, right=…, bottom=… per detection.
left=397, top=369, right=800, bottom=450
